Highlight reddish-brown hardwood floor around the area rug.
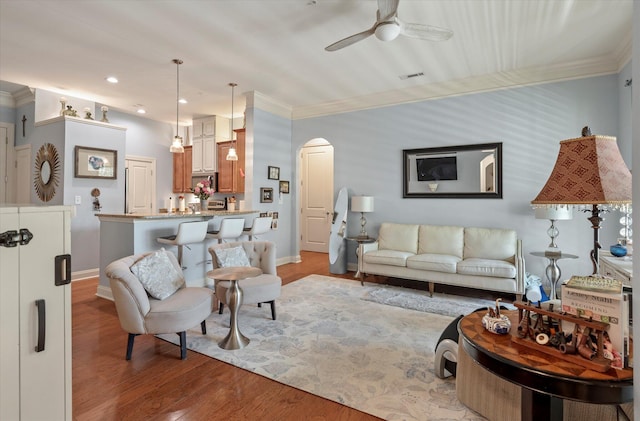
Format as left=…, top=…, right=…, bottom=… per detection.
left=72, top=252, right=502, bottom=421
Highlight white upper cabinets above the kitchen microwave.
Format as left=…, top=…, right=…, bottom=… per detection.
left=192, top=116, right=231, bottom=174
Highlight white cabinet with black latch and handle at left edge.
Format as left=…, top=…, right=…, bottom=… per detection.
left=0, top=205, right=72, bottom=421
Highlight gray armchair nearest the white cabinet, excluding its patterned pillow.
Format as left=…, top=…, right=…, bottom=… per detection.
left=105, top=253, right=213, bottom=360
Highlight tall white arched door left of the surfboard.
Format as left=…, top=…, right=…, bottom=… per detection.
left=300, top=144, right=333, bottom=253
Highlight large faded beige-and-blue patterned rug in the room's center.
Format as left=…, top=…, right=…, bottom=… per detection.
left=159, top=275, right=484, bottom=420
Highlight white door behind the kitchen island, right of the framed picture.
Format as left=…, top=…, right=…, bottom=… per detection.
left=125, top=157, right=156, bottom=213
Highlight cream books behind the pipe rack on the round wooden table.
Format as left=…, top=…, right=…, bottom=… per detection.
left=562, top=276, right=633, bottom=368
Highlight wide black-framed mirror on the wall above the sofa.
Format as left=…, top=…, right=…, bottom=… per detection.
left=402, top=143, right=502, bottom=199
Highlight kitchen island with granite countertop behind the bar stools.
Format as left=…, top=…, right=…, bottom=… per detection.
left=96, top=210, right=258, bottom=300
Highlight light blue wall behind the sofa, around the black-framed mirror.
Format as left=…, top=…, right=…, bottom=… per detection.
left=293, top=75, right=630, bottom=275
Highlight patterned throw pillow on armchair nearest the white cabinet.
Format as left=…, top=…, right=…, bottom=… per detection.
left=131, top=249, right=184, bottom=300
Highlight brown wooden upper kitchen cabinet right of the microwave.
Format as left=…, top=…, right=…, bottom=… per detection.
left=217, top=129, right=245, bottom=193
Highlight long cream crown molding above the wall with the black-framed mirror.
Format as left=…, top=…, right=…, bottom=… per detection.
left=292, top=55, right=631, bottom=120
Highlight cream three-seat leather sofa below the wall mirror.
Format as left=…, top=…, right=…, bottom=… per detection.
left=359, top=222, right=525, bottom=299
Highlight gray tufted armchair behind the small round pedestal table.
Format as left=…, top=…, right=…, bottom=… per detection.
left=209, top=241, right=282, bottom=320
